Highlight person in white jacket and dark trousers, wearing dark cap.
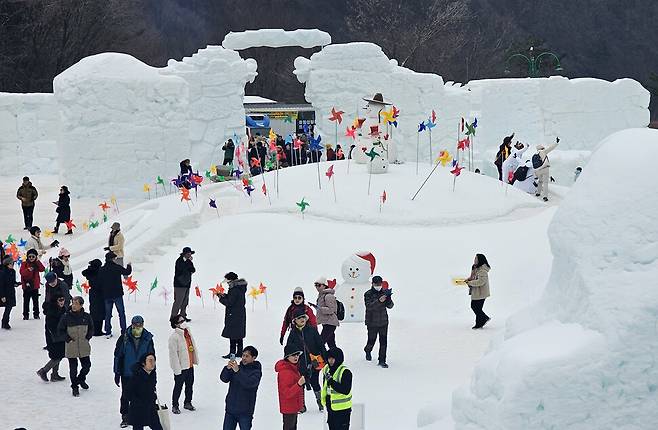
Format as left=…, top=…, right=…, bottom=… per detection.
left=169, top=315, right=199, bottom=414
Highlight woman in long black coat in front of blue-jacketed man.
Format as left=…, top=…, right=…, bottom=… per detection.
left=129, top=352, right=162, bottom=430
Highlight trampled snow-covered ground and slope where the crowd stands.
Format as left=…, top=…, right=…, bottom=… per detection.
left=0, top=162, right=564, bottom=430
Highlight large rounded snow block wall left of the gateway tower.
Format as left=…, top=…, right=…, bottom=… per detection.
left=53, top=53, right=190, bottom=198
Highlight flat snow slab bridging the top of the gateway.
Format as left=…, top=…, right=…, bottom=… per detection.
left=222, top=28, right=331, bottom=51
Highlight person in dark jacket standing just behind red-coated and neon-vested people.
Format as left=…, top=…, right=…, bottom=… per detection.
left=286, top=309, right=327, bottom=412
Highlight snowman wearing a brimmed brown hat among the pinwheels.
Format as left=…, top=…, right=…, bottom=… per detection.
left=352, top=93, right=392, bottom=174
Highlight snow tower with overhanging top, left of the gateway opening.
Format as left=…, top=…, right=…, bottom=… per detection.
left=160, top=46, right=258, bottom=164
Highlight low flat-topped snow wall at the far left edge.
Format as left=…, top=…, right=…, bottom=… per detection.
left=0, top=93, right=59, bottom=176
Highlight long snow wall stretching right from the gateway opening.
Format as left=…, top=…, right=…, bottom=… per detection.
left=294, top=42, right=649, bottom=183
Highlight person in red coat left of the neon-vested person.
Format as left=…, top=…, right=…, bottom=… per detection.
left=274, top=345, right=306, bottom=430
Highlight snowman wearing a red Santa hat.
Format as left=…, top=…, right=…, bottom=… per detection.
left=336, top=252, right=376, bottom=322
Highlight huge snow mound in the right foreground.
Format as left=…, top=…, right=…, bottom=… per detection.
left=453, top=129, right=658, bottom=430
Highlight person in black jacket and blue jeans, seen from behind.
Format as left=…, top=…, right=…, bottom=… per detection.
left=98, top=251, right=133, bottom=338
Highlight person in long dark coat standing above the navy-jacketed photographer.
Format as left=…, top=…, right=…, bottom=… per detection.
left=218, top=272, right=247, bottom=358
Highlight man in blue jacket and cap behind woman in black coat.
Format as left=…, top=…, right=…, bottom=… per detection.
left=114, top=315, right=155, bottom=428
